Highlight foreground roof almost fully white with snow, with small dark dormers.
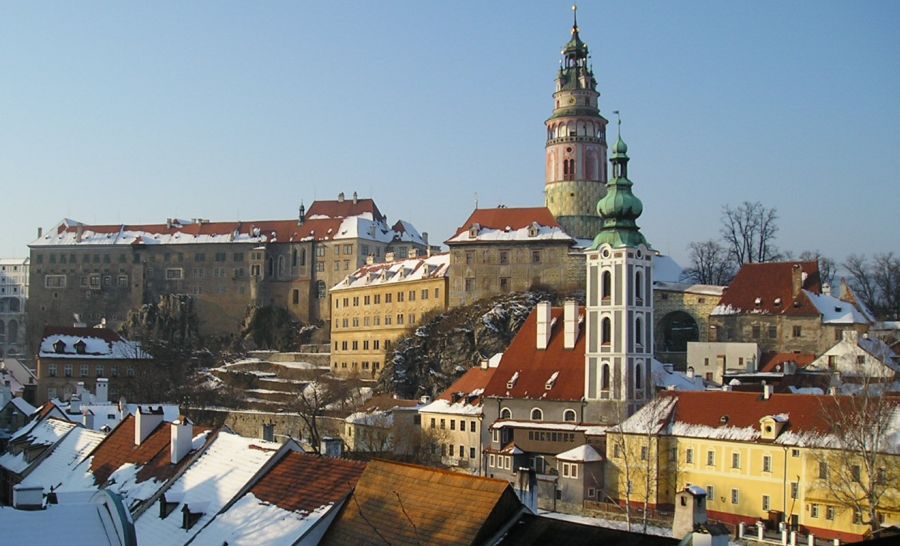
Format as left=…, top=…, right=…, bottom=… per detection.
left=135, top=430, right=281, bottom=544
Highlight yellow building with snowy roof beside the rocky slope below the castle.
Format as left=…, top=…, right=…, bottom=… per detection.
left=330, top=252, right=450, bottom=379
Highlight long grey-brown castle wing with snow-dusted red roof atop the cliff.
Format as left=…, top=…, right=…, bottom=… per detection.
left=28, top=193, right=427, bottom=350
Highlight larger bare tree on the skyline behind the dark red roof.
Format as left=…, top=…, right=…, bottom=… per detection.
left=721, top=201, right=779, bottom=267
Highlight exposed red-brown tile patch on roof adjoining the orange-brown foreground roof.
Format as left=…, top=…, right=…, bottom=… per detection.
left=250, top=451, right=366, bottom=512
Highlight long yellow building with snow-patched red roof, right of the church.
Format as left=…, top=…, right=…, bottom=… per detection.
left=605, top=391, right=900, bottom=541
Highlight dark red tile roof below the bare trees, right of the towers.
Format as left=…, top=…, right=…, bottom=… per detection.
left=713, top=261, right=822, bottom=316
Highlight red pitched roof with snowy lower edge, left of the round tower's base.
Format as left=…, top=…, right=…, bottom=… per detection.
left=446, top=207, right=574, bottom=244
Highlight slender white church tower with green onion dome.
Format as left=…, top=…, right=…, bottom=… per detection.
left=584, top=120, right=653, bottom=416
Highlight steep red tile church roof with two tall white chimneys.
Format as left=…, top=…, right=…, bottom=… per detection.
left=484, top=307, right=585, bottom=400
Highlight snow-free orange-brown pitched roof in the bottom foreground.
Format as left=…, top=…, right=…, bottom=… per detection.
left=322, top=460, right=521, bottom=546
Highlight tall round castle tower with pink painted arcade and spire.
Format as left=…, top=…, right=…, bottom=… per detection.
left=545, top=6, right=607, bottom=239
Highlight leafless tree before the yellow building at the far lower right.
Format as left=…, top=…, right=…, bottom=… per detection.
left=814, top=378, right=900, bottom=531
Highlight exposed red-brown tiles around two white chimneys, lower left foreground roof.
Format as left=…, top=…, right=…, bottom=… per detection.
left=91, top=415, right=209, bottom=485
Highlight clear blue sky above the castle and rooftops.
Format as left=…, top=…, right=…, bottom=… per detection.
left=0, top=0, right=900, bottom=262
